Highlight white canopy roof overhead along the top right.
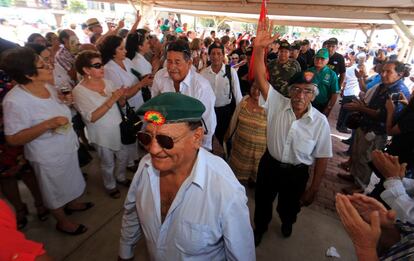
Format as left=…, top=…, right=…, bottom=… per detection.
left=122, top=0, right=414, bottom=60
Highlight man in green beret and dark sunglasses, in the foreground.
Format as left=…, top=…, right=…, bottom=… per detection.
left=119, top=92, right=255, bottom=260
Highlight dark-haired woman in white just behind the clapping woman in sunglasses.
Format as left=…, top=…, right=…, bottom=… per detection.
left=97, top=35, right=152, bottom=169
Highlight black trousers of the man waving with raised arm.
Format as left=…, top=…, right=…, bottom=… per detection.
left=254, top=150, right=309, bottom=233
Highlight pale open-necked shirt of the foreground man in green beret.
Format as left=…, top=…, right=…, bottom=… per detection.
left=119, top=148, right=255, bottom=261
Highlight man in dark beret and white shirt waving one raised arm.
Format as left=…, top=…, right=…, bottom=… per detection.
left=254, top=21, right=332, bottom=246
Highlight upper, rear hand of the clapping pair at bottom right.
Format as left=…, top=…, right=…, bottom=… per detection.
left=347, top=193, right=395, bottom=228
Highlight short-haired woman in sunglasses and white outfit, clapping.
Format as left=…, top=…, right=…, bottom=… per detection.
left=72, top=51, right=150, bottom=198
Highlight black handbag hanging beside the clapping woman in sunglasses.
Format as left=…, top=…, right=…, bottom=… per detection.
left=116, top=101, right=142, bottom=145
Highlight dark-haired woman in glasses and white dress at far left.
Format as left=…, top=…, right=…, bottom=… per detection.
left=0, top=48, right=93, bottom=235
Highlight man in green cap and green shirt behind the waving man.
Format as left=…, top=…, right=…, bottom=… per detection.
left=309, top=48, right=340, bottom=117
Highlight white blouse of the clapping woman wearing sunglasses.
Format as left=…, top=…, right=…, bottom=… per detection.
left=72, top=80, right=122, bottom=151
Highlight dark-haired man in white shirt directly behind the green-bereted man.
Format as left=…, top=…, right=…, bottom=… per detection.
left=151, top=40, right=217, bottom=150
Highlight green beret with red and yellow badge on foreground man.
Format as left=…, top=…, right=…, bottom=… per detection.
left=137, top=92, right=206, bottom=125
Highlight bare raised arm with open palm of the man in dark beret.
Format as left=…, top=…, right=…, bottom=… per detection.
left=253, top=18, right=279, bottom=100
